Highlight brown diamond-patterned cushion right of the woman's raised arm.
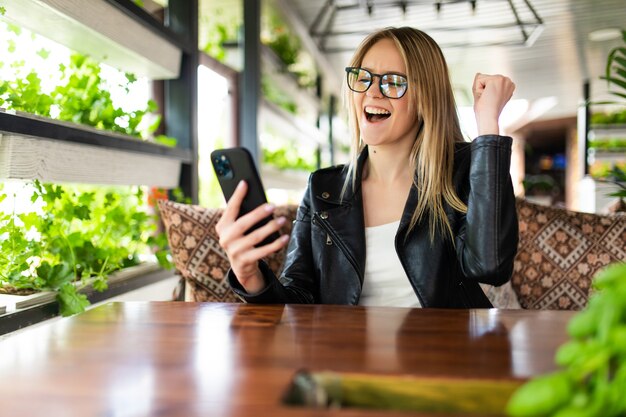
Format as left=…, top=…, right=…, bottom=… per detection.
left=511, top=199, right=626, bottom=310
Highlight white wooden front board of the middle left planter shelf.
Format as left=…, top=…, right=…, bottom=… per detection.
left=0, top=134, right=181, bottom=188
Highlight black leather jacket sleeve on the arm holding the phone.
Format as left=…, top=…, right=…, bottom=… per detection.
left=228, top=173, right=318, bottom=304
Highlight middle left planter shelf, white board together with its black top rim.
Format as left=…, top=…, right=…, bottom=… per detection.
left=0, top=112, right=191, bottom=188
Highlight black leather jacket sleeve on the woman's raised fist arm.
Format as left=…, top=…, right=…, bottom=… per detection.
left=456, top=135, right=518, bottom=285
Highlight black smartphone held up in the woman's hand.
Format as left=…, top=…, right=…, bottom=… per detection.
left=211, top=147, right=280, bottom=247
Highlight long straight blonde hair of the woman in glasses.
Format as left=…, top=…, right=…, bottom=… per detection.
left=344, top=27, right=467, bottom=242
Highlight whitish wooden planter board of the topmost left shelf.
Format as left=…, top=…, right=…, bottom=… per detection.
left=4, top=0, right=182, bottom=79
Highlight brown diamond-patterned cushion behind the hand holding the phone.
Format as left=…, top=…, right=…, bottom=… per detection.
left=158, top=200, right=297, bottom=302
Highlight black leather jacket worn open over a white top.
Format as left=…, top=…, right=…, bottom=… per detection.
left=228, top=135, right=518, bottom=308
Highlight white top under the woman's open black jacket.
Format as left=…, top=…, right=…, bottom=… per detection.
left=359, top=220, right=421, bottom=307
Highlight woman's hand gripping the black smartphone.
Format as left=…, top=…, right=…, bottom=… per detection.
left=215, top=181, right=289, bottom=294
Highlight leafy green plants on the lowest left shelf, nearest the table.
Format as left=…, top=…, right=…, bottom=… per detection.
left=0, top=181, right=171, bottom=315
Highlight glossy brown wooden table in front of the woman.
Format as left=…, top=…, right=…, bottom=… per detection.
left=0, top=302, right=572, bottom=417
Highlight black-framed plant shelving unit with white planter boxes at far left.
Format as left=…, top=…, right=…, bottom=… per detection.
left=0, top=0, right=199, bottom=324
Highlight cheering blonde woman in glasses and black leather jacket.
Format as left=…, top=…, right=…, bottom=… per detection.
left=216, top=27, right=517, bottom=308
